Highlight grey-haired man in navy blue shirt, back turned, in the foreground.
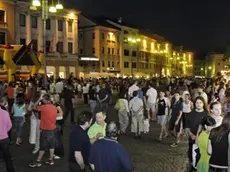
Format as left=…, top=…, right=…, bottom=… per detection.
left=89, top=122, right=133, bottom=172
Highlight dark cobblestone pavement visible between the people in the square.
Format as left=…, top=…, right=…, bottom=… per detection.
left=0, top=101, right=187, bottom=172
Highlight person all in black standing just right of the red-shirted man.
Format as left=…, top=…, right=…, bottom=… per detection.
left=62, top=83, right=75, bottom=124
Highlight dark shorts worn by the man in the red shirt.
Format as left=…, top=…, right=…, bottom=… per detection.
left=40, top=129, right=56, bottom=150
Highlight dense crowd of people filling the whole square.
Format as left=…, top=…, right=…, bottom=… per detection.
left=0, top=76, right=230, bottom=172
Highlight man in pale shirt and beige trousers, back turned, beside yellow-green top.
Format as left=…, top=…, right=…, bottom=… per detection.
left=129, top=91, right=144, bottom=138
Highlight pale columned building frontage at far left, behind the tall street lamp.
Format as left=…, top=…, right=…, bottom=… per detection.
left=0, top=1, right=79, bottom=78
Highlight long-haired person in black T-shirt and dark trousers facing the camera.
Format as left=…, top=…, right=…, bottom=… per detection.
left=186, top=96, right=208, bottom=172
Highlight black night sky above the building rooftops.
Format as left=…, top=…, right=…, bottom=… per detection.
left=65, top=0, right=230, bottom=54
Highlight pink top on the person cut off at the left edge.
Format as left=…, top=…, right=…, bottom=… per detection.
left=0, top=108, right=12, bottom=140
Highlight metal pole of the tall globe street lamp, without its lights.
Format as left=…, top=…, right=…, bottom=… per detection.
left=42, top=0, right=48, bottom=89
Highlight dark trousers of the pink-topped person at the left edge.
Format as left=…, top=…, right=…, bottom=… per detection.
left=0, top=138, right=14, bottom=172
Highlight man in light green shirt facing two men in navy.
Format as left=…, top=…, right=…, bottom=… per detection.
left=88, top=112, right=107, bottom=144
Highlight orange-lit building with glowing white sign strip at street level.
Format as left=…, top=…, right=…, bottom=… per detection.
left=78, top=15, right=121, bottom=77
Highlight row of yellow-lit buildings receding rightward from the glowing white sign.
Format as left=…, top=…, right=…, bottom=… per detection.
left=79, top=14, right=194, bottom=78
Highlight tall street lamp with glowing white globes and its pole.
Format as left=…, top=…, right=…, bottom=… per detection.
left=31, top=0, right=63, bottom=89
